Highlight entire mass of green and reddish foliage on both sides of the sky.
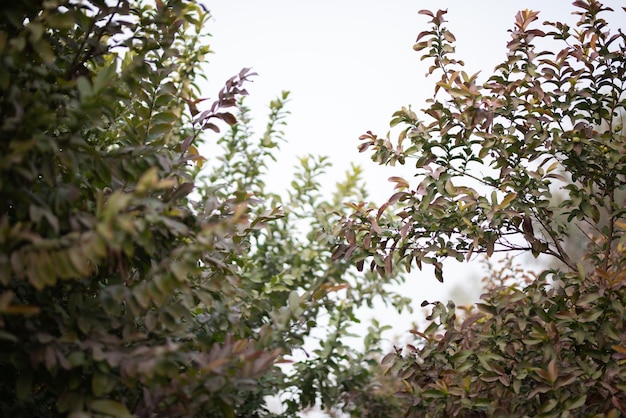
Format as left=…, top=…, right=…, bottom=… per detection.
left=0, top=0, right=626, bottom=418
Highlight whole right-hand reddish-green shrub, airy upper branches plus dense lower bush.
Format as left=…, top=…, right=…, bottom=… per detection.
left=337, top=0, right=626, bottom=417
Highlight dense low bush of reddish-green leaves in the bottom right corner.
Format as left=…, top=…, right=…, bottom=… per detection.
left=390, top=258, right=626, bottom=417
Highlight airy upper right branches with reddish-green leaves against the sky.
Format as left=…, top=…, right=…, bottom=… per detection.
left=341, top=1, right=626, bottom=280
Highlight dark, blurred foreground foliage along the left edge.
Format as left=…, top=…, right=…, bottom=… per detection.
left=0, top=1, right=270, bottom=417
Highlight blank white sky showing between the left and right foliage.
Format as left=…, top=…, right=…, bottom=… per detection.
left=197, top=0, right=626, bottom=414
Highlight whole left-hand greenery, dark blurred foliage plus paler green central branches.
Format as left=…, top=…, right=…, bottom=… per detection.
left=0, top=0, right=406, bottom=418
